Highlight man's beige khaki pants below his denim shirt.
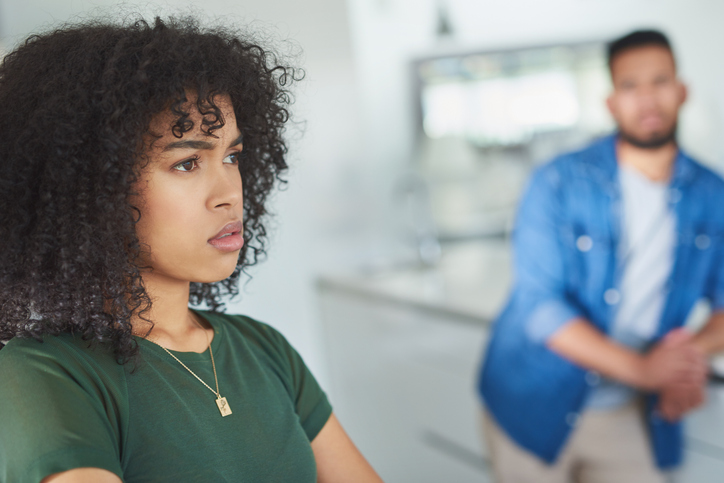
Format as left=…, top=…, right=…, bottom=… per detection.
left=481, top=403, right=668, bottom=483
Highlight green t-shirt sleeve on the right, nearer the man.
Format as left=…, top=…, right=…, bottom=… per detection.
left=265, top=325, right=332, bottom=441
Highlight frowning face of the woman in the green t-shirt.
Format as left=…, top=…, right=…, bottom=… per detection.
left=131, top=96, right=243, bottom=283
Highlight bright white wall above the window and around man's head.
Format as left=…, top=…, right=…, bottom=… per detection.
left=348, top=0, right=724, bottom=169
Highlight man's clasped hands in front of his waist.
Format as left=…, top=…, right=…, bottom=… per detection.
left=637, top=329, right=708, bottom=394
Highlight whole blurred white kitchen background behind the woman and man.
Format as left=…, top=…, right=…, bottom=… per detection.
left=0, top=0, right=724, bottom=483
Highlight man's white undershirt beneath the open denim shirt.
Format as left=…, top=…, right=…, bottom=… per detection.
left=588, top=165, right=676, bottom=409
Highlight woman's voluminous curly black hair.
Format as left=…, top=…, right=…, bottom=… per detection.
left=0, top=18, right=299, bottom=362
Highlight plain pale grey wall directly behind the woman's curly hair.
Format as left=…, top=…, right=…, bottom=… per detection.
left=0, top=0, right=367, bottom=385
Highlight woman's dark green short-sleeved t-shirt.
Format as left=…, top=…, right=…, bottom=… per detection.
left=0, top=311, right=332, bottom=483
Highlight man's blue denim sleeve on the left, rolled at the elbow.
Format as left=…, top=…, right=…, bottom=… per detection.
left=513, top=164, right=582, bottom=343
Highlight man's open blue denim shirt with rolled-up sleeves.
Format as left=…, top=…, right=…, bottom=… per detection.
left=478, top=135, right=724, bottom=468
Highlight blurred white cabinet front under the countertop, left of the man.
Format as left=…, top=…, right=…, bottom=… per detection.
left=321, top=288, right=488, bottom=483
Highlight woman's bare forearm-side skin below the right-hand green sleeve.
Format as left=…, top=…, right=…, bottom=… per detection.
left=312, top=414, right=382, bottom=483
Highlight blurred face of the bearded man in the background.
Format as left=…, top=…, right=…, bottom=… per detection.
left=607, top=45, right=686, bottom=148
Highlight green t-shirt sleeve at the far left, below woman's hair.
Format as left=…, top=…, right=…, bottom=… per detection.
left=0, top=340, right=122, bottom=483
